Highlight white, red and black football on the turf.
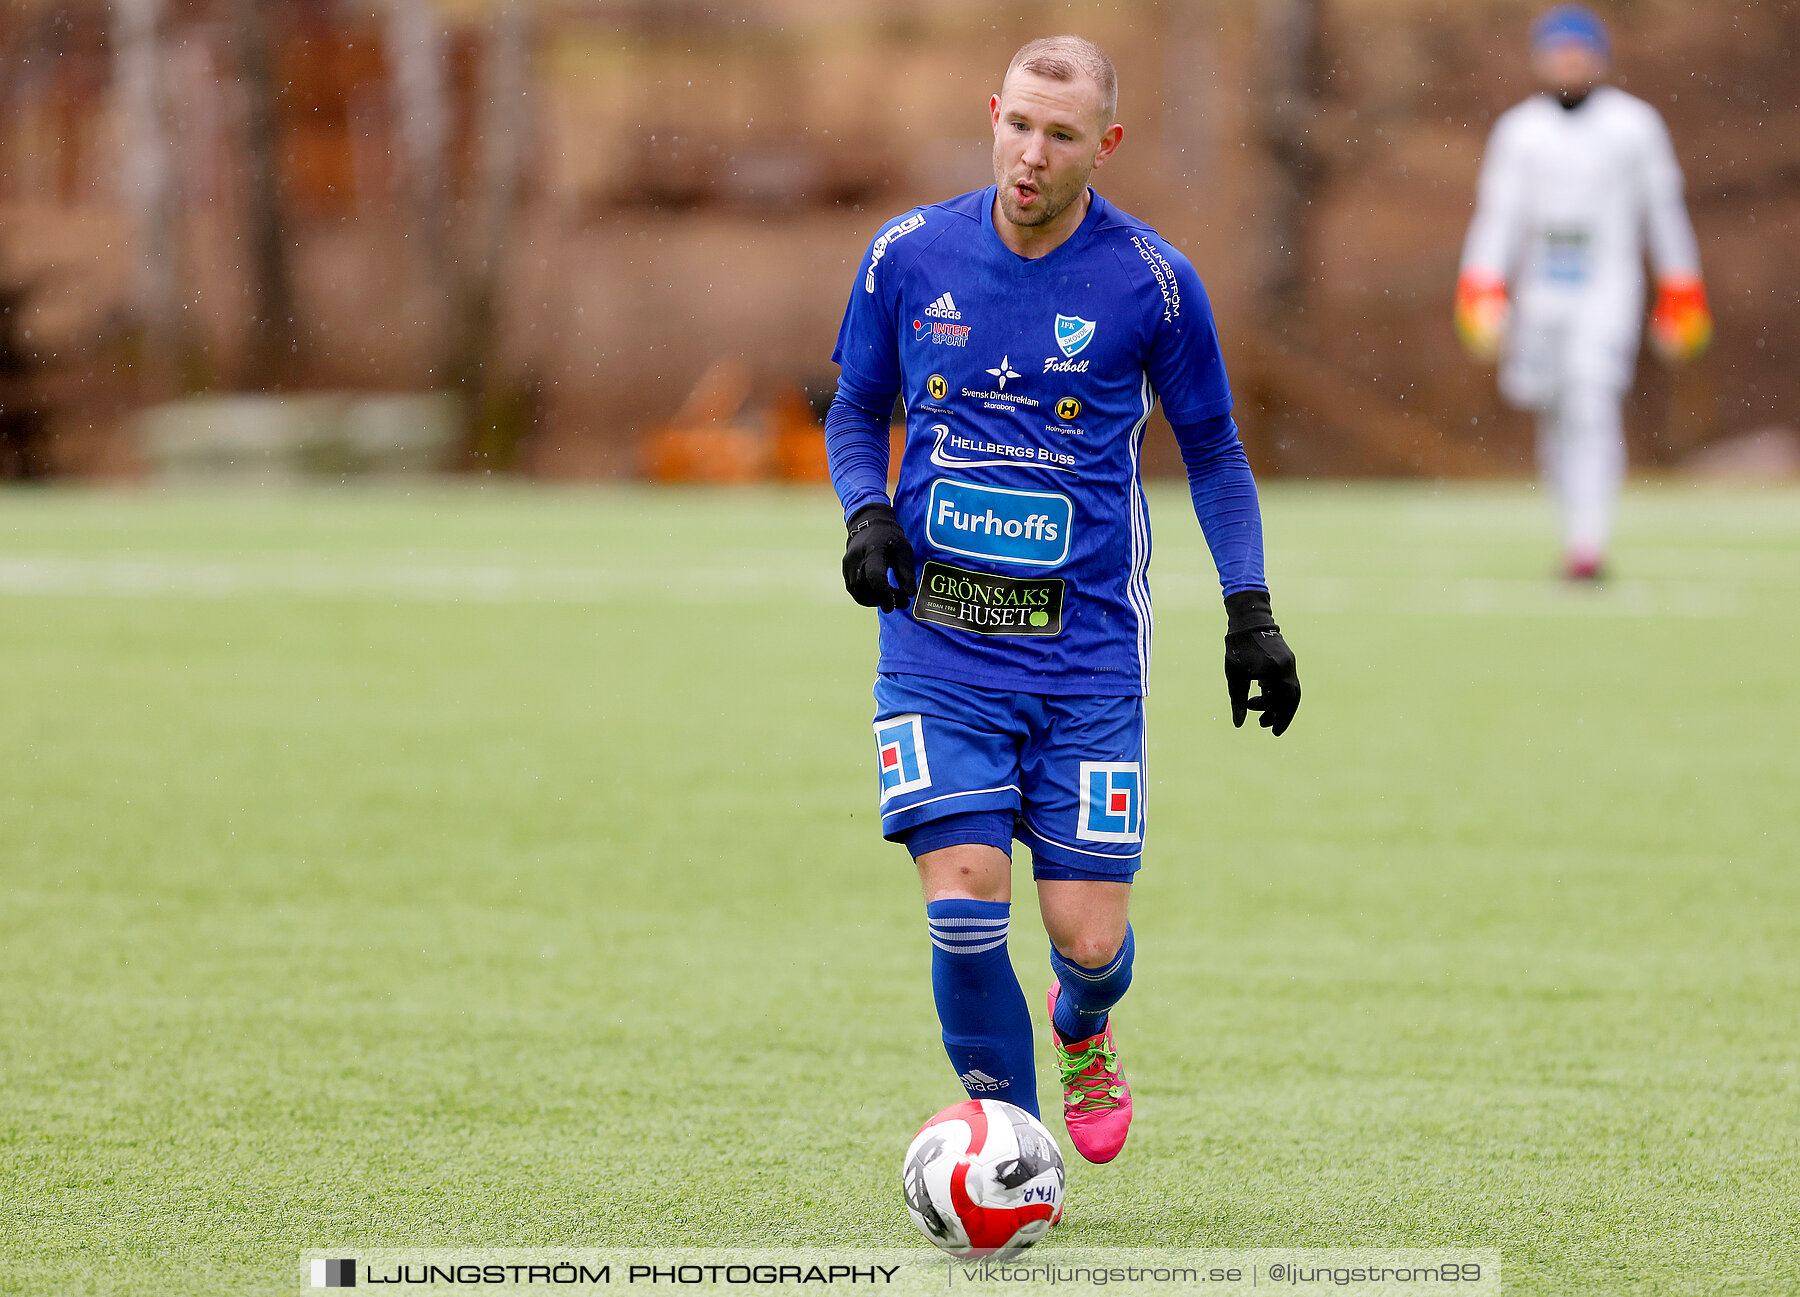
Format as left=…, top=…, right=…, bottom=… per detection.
left=900, top=1099, right=1064, bottom=1259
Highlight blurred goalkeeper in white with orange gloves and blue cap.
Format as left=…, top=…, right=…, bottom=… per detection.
left=1456, top=5, right=1712, bottom=579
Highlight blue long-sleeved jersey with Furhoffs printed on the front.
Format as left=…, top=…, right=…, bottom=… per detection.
left=826, top=189, right=1265, bottom=696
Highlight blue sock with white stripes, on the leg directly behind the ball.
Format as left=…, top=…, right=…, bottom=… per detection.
left=925, top=899, right=1037, bottom=1117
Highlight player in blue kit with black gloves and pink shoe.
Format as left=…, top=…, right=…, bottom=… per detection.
left=826, top=36, right=1300, bottom=1162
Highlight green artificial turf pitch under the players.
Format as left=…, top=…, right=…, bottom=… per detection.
left=0, top=486, right=1800, bottom=1295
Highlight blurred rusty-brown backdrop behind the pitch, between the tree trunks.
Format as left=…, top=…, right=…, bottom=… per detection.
left=0, top=0, right=1800, bottom=475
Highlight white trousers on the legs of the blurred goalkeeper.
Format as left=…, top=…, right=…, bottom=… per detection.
left=1537, top=383, right=1625, bottom=559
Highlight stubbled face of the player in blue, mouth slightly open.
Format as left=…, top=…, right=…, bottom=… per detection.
left=994, top=72, right=1100, bottom=225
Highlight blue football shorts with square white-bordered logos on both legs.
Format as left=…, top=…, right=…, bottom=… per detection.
left=875, top=675, right=1145, bottom=881
